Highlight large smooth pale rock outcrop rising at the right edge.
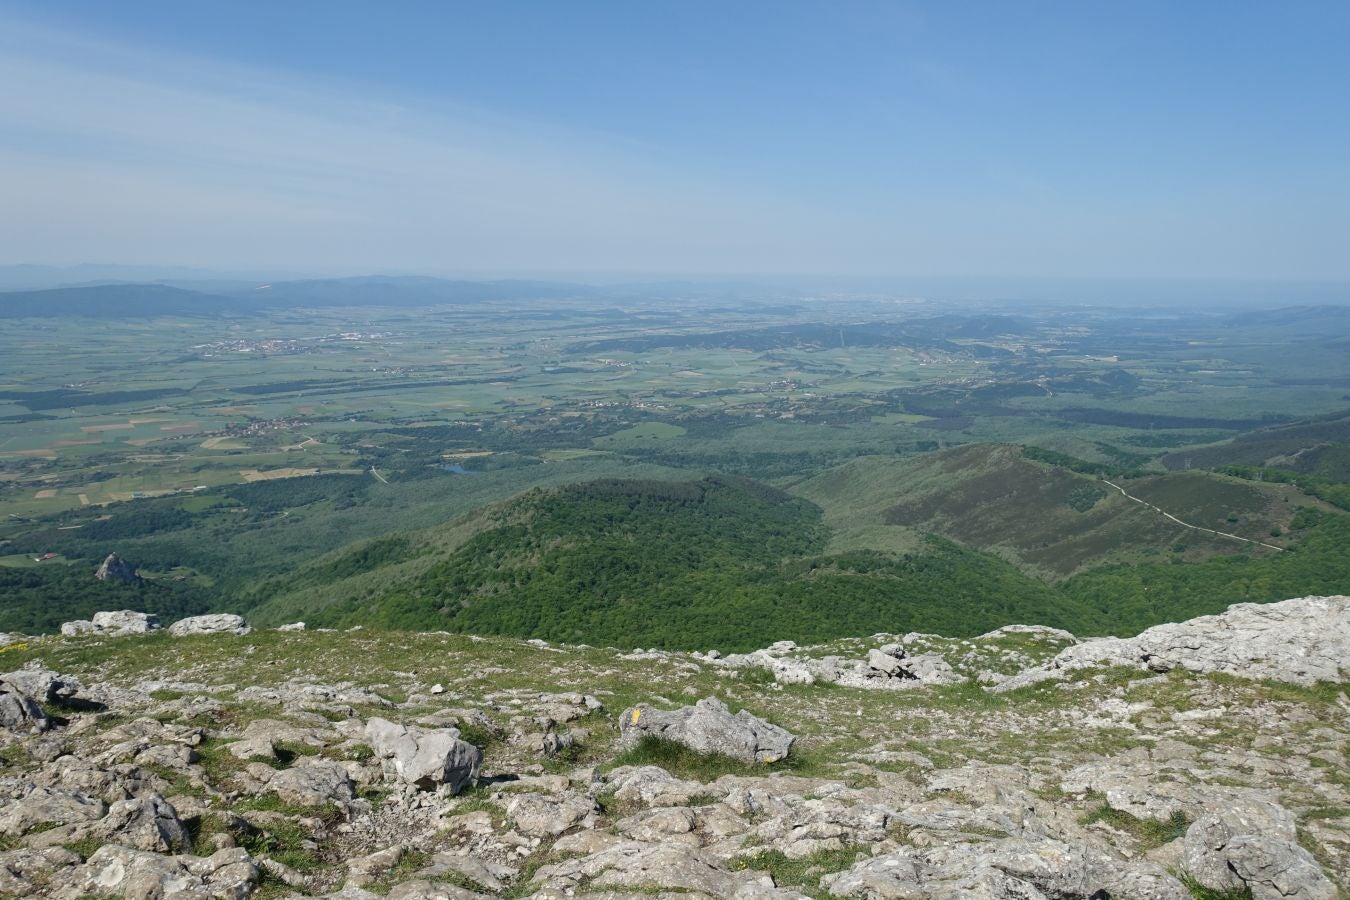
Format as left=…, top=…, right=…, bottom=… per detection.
left=994, top=595, right=1350, bottom=692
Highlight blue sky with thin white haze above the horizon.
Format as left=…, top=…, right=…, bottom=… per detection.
left=0, top=0, right=1350, bottom=281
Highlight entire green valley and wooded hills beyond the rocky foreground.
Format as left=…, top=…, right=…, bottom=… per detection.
left=0, top=296, right=1350, bottom=649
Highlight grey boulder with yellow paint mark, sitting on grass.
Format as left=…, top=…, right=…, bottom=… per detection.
left=618, top=698, right=797, bottom=762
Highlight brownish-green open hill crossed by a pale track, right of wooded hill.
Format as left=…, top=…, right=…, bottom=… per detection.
left=792, top=444, right=1311, bottom=580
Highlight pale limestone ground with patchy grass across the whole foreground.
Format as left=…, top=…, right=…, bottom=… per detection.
left=0, top=596, right=1350, bottom=900
